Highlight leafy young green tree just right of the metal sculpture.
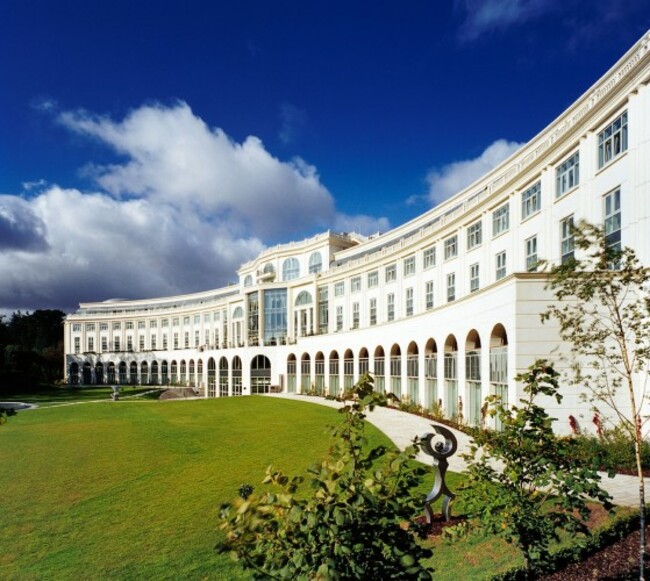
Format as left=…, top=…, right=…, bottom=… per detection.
left=451, top=360, right=610, bottom=575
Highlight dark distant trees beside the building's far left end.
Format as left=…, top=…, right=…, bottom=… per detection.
left=0, top=310, right=65, bottom=393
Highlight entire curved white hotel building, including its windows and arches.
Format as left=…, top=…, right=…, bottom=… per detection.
left=65, top=32, right=650, bottom=429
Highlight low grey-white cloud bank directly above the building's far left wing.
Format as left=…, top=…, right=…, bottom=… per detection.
left=0, top=186, right=264, bottom=310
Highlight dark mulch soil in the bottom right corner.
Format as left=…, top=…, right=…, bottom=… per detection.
left=543, top=525, right=650, bottom=581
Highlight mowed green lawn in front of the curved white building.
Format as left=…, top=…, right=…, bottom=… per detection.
left=0, top=397, right=389, bottom=579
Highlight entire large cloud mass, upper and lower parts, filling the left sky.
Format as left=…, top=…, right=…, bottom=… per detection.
left=0, top=103, right=388, bottom=310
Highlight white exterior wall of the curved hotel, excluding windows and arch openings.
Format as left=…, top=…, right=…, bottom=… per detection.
left=65, top=34, right=650, bottom=424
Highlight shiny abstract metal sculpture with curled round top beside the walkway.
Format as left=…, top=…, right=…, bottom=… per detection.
left=420, top=424, right=458, bottom=524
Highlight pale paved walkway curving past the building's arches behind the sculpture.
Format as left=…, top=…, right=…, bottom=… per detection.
left=268, top=393, right=650, bottom=507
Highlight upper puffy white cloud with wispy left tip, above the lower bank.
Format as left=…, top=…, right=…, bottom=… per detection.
left=59, top=103, right=344, bottom=237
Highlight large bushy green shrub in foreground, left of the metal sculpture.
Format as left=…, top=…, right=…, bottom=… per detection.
left=217, top=374, right=431, bottom=579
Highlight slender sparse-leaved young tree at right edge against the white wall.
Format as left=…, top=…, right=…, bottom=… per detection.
left=542, top=222, right=650, bottom=578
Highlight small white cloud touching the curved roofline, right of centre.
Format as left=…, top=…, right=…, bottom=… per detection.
left=427, top=139, right=524, bottom=205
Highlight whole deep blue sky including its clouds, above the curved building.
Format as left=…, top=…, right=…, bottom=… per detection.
left=0, top=0, right=650, bottom=311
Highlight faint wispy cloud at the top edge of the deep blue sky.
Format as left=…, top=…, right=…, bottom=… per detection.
left=456, top=0, right=558, bottom=41
